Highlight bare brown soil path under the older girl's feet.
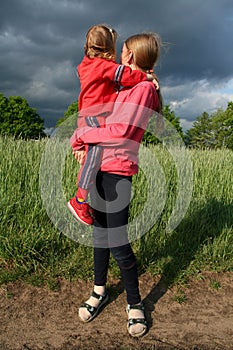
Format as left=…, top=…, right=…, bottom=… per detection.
left=0, top=273, right=233, bottom=350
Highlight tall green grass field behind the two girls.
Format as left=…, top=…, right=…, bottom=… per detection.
left=0, top=137, right=233, bottom=287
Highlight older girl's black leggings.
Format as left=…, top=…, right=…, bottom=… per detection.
left=91, top=171, right=141, bottom=305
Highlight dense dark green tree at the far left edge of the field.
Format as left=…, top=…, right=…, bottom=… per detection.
left=0, top=93, right=46, bottom=139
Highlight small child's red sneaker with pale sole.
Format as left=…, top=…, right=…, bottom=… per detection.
left=67, top=197, right=94, bottom=225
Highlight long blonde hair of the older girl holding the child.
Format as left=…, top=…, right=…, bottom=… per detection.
left=125, top=32, right=163, bottom=113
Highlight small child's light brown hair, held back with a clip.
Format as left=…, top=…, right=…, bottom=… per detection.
left=84, top=24, right=117, bottom=61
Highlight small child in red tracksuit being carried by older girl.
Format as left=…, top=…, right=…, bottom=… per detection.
left=68, top=24, right=157, bottom=225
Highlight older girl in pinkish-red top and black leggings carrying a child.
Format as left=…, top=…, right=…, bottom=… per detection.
left=71, top=33, right=161, bottom=337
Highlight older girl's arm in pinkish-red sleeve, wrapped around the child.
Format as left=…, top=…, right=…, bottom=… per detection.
left=70, top=84, right=158, bottom=149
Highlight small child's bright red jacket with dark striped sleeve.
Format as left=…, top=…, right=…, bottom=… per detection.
left=77, top=56, right=147, bottom=126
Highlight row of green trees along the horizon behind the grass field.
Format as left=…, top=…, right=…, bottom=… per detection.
left=0, top=93, right=233, bottom=149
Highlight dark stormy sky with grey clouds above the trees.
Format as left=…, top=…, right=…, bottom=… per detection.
left=0, top=0, right=233, bottom=130
